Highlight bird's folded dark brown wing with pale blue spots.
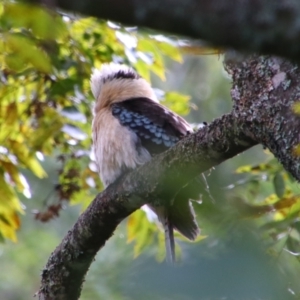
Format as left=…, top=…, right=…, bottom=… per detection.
left=111, top=98, right=192, bottom=155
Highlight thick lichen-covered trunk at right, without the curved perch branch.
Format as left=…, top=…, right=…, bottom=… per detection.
left=227, top=56, right=300, bottom=181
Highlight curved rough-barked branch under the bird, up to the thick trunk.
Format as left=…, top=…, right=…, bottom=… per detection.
left=39, top=114, right=256, bottom=300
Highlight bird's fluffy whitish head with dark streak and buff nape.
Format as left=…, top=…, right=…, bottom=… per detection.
left=91, top=63, right=157, bottom=113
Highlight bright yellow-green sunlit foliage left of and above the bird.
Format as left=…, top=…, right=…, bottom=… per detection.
left=0, top=1, right=189, bottom=241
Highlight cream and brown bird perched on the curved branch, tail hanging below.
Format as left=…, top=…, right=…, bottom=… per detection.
left=91, top=63, right=199, bottom=262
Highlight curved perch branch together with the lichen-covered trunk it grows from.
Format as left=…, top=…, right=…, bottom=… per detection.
left=39, top=56, right=300, bottom=300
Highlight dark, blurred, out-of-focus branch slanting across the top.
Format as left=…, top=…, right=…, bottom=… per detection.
left=31, top=0, right=300, bottom=60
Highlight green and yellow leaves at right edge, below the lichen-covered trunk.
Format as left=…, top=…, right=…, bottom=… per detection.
left=235, top=158, right=300, bottom=260
